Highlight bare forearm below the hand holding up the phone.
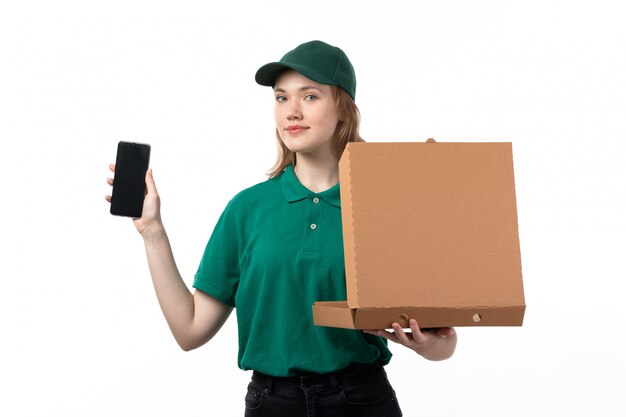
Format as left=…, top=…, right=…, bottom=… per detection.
left=143, top=226, right=194, bottom=349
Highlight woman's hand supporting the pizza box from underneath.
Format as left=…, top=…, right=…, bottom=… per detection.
left=363, top=319, right=456, bottom=361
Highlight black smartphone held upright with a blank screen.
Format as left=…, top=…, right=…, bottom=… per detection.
left=111, top=141, right=150, bottom=218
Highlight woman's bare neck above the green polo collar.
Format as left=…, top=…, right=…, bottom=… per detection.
left=294, top=154, right=339, bottom=193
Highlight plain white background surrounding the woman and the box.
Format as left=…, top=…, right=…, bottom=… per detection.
left=0, top=0, right=626, bottom=417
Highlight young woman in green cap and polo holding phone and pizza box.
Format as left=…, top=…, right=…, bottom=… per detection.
left=107, top=41, right=456, bottom=417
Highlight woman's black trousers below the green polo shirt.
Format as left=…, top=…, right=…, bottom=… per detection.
left=245, top=362, right=402, bottom=417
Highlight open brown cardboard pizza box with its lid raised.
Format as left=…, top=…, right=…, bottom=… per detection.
left=313, top=142, right=526, bottom=329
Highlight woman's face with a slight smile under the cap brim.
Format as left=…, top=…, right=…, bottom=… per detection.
left=274, top=71, right=338, bottom=156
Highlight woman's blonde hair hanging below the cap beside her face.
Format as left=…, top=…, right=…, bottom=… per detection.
left=267, top=85, right=364, bottom=178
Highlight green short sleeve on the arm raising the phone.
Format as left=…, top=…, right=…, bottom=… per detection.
left=193, top=201, right=240, bottom=307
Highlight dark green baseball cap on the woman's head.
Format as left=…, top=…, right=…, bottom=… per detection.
left=254, top=41, right=356, bottom=100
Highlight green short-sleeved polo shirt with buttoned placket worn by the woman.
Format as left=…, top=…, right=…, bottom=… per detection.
left=193, top=165, right=391, bottom=376
